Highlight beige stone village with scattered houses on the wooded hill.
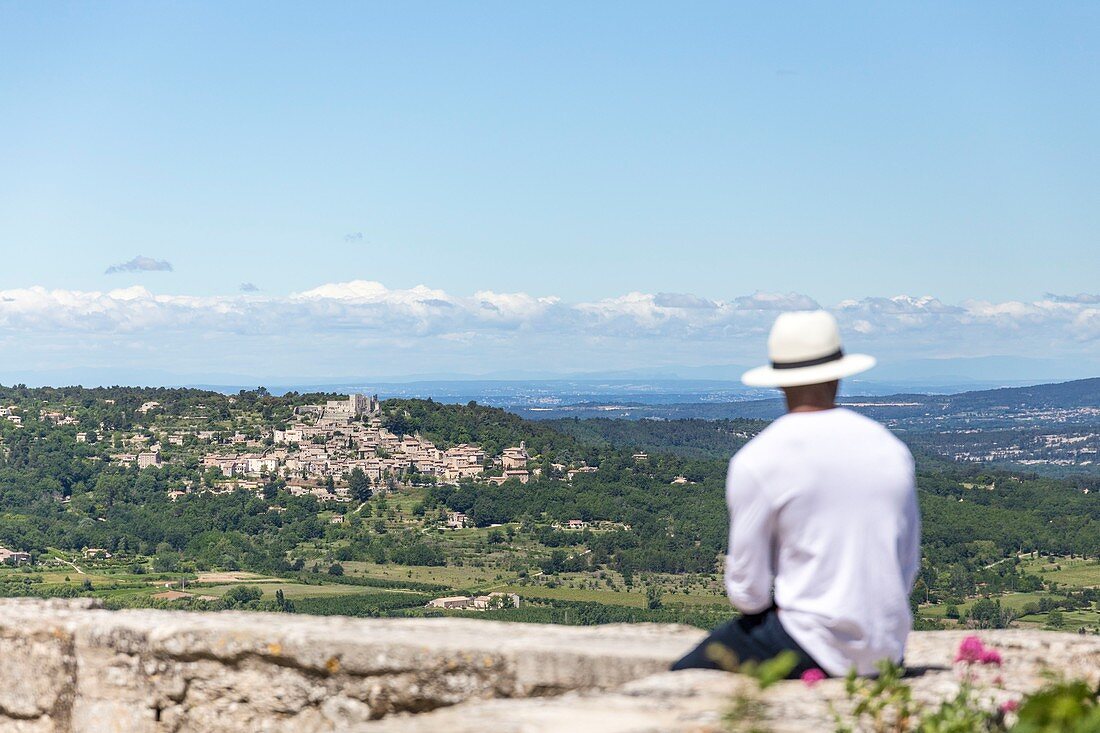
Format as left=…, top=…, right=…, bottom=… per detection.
left=0, top=394, right=602, bottom=517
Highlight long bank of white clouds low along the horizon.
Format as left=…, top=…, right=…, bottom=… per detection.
left=0, top=281, right=1100, bottom=375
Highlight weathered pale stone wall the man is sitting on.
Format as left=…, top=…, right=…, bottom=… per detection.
left=0, top=599, right=1100, bottom=733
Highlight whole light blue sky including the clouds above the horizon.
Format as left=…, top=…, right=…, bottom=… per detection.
left=0, top=2, right=1100, bottom=383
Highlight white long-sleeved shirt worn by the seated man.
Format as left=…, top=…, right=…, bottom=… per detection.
left=725, top=407, right=921, bottom=676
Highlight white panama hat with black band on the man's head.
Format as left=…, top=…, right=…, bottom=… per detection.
left=741, top=310, right=876, bottom=387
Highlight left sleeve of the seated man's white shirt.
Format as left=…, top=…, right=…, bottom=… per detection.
left=725, top=458, right=774, bottom=613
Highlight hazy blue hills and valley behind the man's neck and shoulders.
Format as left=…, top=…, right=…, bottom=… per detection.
left=528, top=378, right=1100, bottom=475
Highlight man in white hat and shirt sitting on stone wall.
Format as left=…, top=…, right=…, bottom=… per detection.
left=672, top=310, right=921, bottom=676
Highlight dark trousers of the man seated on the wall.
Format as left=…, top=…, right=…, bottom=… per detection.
left=672, top=606, right=821, bottom=678
